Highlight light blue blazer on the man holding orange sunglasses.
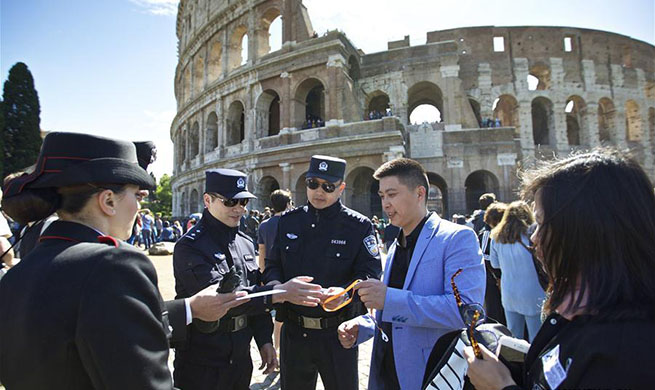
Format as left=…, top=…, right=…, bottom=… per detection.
left=357, top=214, right=486, bottom=390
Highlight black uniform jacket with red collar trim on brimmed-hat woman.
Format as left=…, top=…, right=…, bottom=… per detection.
left=0, top=221, right=173, bottom=390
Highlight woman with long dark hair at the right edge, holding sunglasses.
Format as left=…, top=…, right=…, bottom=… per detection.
left=465, top=149, right=655, bottom=390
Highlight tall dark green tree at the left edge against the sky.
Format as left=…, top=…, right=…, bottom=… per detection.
left=2, top=62, right=42, bottom=177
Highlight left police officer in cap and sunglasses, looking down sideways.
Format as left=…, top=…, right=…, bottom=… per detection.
left=173, top=169, right=278, bottom=390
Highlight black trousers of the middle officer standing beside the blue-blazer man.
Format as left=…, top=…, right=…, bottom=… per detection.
left=280, top=322, right=359, bottom=390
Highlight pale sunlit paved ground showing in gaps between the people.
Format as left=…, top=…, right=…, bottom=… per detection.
left=150, top=256, right=373, bottom=390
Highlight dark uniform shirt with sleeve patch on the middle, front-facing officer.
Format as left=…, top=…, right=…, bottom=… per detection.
left=264, top=201, right=382, bottom=325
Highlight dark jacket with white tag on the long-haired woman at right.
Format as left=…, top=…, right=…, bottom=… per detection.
left=521, top=314, right=655, bottom=390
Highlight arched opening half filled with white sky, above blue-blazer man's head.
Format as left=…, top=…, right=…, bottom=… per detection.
left=407, top=81, right=445, bottom=124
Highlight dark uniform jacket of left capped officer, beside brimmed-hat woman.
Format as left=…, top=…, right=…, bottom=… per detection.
left=173, top=210, right=273, bottom=366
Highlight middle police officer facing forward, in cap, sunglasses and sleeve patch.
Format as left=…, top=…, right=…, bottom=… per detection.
left=264, top=155, right=382, bottom=390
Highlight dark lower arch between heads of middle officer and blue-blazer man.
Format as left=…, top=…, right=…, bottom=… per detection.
left=346, top=167, right=382, bottom=218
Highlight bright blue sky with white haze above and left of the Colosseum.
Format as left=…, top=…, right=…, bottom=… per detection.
left=0, top=0, right=655, bottom=176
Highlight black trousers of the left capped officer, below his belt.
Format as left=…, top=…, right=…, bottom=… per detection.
left=173, top=355, right=252, bottom=390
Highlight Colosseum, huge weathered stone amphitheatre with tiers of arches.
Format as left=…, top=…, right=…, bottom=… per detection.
left=170, top=0, right=655, bottom=216
